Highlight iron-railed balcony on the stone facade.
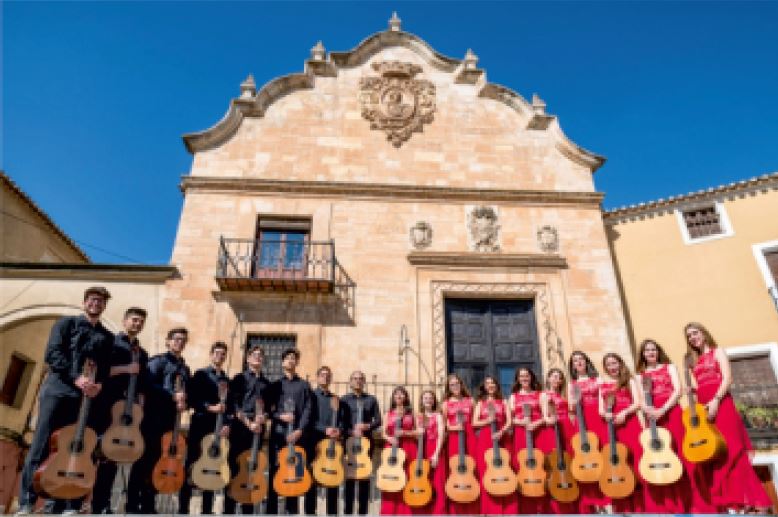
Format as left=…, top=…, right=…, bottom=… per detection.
left=216, top=237, right=338, bottom=293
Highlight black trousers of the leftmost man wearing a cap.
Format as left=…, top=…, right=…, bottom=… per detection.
left=19, top=377, right=85, bottom=512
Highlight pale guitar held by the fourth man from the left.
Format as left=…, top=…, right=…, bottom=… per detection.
left=192, top=381, right=230, bottom=491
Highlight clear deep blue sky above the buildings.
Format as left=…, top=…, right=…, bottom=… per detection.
left=0, top=2, right=778, bottom=263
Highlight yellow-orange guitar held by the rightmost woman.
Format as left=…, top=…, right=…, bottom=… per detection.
left=681, top=357, right=727, bottom=463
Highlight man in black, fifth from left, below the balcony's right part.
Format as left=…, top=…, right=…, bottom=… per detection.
left=224, top=344, right=272, bottom=515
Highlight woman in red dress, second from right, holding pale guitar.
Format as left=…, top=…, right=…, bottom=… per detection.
left=637, top=339, right=704, bottom=513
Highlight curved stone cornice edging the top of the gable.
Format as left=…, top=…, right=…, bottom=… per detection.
left=183, top=29, right=605, bottom=172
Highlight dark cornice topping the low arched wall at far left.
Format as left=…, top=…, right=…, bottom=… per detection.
left=0, top=262, right=178, bottom=284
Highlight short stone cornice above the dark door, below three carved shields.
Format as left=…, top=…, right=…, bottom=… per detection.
left=408, top=251, right=567, bottom=269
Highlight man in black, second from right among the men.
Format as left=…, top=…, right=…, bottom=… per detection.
left=305, top=366, right=345, bottom=515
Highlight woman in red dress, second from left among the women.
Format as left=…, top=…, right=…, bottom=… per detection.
left=413, top=390, right=446, bottom=515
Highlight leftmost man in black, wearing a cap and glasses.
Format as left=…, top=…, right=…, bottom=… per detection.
left=18, top=287, right=114, bottom=515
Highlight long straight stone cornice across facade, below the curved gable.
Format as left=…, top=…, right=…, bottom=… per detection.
left=181, top=176, right=603, bottom=208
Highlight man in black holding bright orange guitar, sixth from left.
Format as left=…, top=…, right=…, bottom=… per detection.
left=267, top=348, right=312, bottom=515
